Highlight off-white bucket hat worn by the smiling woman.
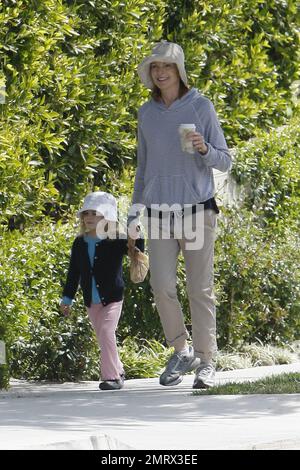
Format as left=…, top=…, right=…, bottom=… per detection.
left=138, top=41, right=188, bottom=90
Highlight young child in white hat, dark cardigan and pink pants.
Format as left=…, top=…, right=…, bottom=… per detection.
left=60, top=191, right=144, bottom=390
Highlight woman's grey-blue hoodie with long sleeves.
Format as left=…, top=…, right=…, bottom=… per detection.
left=132, top=88, right=231, bottom=207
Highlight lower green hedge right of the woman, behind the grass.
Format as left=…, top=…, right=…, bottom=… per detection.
left=216, top=118, right=300, bottom=346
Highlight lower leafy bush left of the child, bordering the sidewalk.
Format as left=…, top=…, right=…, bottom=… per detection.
left=0, top=221, right=98, bottom=380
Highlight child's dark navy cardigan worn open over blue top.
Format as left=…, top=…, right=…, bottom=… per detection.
left=63, top=236, right=144, bottom=307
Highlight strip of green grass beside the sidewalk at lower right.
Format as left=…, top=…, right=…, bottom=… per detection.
left=193, top=372, right=300, bottom=395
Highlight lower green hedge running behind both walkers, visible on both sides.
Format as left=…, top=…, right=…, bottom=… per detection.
left=0, top=116, right=300, bottom=379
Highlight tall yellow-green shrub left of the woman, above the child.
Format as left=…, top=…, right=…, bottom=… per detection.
left=0, top=0, right=163, bottom=226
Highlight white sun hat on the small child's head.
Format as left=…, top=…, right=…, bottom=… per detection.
left=77, top=191, right=118, bottom=222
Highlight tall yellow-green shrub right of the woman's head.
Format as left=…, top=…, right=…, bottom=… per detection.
left=164, top=0, right=300, bottom=146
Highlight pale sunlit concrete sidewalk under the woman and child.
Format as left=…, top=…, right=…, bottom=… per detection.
left=0, top=363, right=300, bottom=450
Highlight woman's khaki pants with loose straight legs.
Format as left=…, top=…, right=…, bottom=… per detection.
left=148, top=209, right=217, bottom=362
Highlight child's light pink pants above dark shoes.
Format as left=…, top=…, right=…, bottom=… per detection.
left=87, top=300, right=124, bottom=380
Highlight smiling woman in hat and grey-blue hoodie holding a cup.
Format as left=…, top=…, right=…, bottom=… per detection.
left=132, top=41, right=231, bottom=388
